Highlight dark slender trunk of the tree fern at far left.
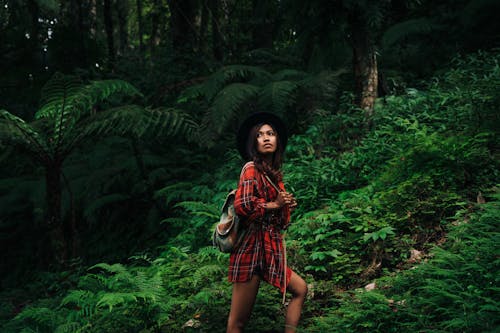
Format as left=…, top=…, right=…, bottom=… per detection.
left=45, top=161, right=68, bottom=265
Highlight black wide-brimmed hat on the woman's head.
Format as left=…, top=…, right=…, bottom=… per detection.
left=236, top=112, right=288, bottom=160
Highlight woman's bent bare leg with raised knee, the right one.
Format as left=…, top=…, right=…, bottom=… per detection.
left=285, top=272, right=307, bottom=333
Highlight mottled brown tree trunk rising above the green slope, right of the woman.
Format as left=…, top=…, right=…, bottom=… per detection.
left=350, top=13, right=378, bottom=126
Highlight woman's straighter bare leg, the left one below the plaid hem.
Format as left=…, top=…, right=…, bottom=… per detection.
left=226, top=275, right=262, bottom=333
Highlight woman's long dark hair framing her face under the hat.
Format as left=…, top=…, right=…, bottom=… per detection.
left=247, top=123, right=283, bottom=182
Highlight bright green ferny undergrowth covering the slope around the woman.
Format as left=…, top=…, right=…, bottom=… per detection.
left=0, top=52, right=500, bottom=332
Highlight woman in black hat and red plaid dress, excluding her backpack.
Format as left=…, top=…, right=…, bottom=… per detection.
left=227, top=113, right=307, bottom=333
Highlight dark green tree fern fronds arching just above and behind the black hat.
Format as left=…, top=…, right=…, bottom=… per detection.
left=178, top=65, right=345, bottom=146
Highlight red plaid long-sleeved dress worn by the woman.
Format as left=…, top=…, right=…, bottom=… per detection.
left=228, top=162, right=292, bottom=292
